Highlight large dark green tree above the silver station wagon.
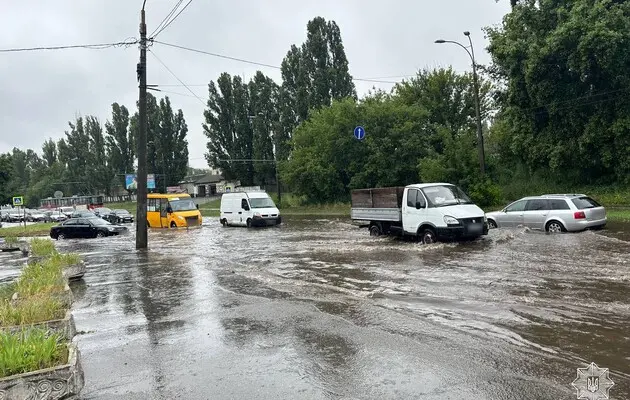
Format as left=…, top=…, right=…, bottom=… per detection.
left=488, top=0, right=630, bottom=184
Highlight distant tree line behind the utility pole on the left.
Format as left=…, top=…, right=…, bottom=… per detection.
left=0, top=93, right=188, bottom=207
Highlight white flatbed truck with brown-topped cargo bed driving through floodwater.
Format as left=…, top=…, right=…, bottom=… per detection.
left=351, top=183, right=488, bottom=244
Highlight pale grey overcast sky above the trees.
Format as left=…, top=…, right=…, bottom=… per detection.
left=0, top=0, right=510, bottom=167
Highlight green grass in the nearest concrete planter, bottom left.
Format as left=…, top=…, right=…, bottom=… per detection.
left=0, top=329, right=68, bottom=378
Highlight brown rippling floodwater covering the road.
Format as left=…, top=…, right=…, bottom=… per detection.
left=0, top=217, right=630, bottom=400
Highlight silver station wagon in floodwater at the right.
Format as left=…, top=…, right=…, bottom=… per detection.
left=486, top=194, right=607, bottom=232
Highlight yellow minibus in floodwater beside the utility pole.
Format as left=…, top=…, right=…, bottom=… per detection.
left=147, top=193, right=202, bottom=228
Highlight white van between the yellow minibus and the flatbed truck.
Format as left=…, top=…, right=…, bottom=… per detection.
left=219, top=191, right=282, bottom=228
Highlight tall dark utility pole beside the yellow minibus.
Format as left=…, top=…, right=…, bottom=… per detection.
left=136, top=0, right=148, bottom=249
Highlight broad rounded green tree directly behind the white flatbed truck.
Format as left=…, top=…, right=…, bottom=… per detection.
left=281, top=94, right=434, bottom=202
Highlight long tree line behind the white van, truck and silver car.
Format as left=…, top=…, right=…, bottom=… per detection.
left=204, top=0, right=630, bottom=205
